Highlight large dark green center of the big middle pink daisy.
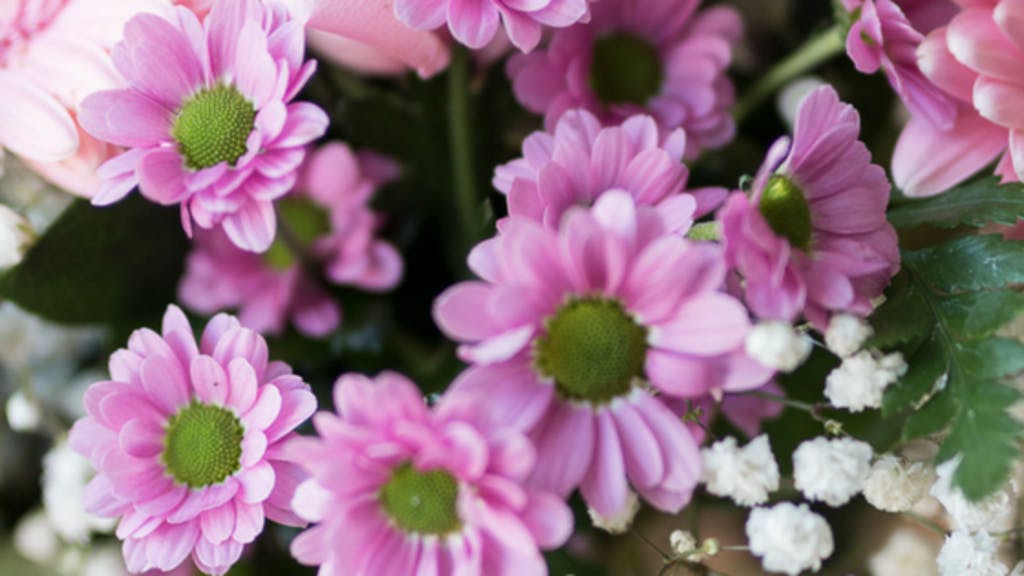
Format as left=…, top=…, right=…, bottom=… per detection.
left=534, top=297, right=647, bottom=404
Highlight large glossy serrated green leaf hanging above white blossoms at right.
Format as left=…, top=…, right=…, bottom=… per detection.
left=873, top=236, right=1024, bottom=499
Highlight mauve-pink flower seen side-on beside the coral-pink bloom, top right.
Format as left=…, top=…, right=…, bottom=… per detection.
left=843, top=0, right=956, bottom=130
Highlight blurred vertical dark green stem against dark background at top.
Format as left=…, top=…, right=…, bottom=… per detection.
left=447, top=47, right=482, bottom=273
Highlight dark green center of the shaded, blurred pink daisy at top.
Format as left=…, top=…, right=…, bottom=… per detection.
left=590, top=32, right=664, bottom=106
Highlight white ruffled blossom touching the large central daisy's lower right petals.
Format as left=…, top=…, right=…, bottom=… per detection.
left=700, top=435, right=779, bottom=506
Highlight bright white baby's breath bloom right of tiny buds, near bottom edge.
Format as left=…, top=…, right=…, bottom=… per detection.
left=746, top=502, right=834, bottom=576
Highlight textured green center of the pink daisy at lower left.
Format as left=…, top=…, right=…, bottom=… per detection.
left=163, top=402, right=245, bottom=488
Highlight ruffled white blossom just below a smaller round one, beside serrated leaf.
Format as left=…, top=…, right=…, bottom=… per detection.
left=825, top=351, right=906, bottom=412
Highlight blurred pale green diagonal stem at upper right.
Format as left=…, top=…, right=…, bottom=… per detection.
left=733, top=26, right=844, bottom=124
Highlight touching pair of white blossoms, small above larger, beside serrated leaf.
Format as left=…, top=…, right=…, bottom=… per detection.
left=825, top=314, right=907, bottom=412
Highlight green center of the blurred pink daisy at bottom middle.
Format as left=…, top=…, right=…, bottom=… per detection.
left=380, top=463, right=462, bottom=536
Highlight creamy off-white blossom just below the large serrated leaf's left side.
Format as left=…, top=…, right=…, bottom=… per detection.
left=864, top=454, right=935, bottom=512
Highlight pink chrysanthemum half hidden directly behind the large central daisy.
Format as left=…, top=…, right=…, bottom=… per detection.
left=494, top=110, right=727, bottom=229
